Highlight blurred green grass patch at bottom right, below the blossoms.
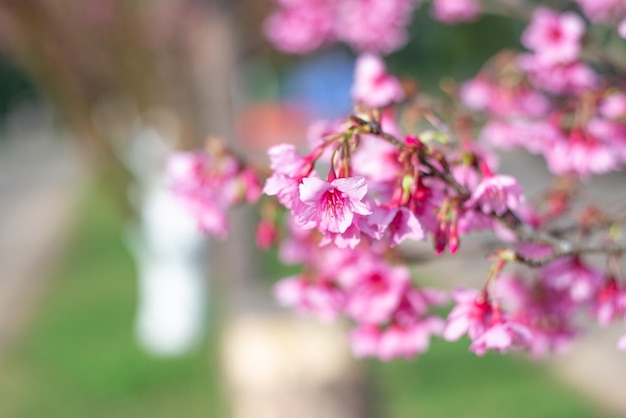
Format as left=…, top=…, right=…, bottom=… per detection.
left=370, top=339, right=602, bottom=418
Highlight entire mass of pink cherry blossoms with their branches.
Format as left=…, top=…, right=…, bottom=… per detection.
left=171, top=0, right=626, bottom=360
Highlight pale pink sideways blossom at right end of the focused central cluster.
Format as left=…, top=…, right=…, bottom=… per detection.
left=466, top=174, right=524, bottom=215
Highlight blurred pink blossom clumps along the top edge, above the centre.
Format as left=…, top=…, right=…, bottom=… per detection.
left=265, top=0, right=481, bottom=54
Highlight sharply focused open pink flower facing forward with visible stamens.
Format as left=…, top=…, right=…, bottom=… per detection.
left=295, top=177, right=371, bottom=233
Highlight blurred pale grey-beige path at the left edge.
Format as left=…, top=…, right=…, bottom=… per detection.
left=0, top=125, right=83, bottom=350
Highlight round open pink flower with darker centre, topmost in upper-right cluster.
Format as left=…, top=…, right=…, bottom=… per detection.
left=522, top=7, right=585, bottom=65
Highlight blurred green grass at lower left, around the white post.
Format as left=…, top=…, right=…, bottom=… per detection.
left=0, top=196, right=219, bottom=418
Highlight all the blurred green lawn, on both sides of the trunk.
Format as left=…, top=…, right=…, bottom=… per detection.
left=0, top=188, right=600, bottom=418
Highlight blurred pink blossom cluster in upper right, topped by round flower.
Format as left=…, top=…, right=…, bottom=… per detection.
left=459, top=2, right=626, bottom=179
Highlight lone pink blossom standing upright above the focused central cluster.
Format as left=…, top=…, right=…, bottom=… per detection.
left=352, top=54, right=404, bottom=107
